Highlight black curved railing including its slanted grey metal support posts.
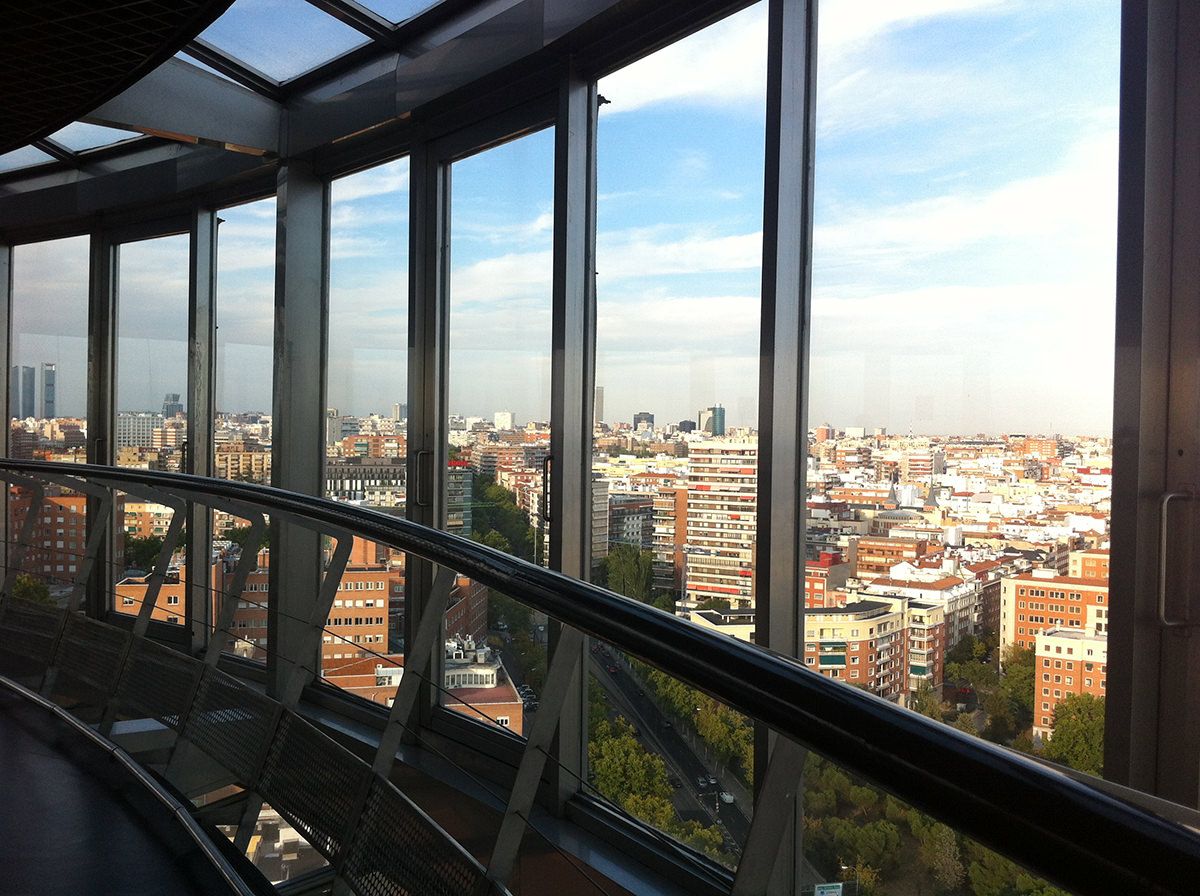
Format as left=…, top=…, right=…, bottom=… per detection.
left=0, top=461, right=1200, bottom=894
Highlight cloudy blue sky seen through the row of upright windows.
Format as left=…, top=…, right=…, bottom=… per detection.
left=9, top=0, right=1118, bottom=433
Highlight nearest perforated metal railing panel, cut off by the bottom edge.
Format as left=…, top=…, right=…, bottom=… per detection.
left=342, top=776, right=484, bottom=896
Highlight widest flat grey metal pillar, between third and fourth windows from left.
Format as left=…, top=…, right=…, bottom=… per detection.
left=268, top=160, right=330, bottom=694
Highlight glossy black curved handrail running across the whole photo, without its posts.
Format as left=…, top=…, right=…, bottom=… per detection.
left=0, top=461, right=1200, bottom=895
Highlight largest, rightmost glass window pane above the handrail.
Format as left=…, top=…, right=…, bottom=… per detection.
left=808, top=0, right=1120, bottom=791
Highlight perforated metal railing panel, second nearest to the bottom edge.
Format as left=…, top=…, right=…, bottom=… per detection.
left=259, top=711, right=371, bottom=861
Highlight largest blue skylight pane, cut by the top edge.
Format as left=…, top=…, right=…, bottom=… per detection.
left=200, top=0, right=370, bottom=80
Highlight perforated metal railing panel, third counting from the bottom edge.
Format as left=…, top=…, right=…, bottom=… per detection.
left=184, top=669, right=282, bottom=788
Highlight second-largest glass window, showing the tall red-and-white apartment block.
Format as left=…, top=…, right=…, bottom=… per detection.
left=588, top=5, right=768, bottom=867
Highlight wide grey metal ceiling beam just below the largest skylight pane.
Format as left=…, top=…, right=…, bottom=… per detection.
left=83, top=59, right=282, bottom=155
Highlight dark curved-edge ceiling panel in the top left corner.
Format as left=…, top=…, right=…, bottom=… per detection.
left=0, top=0, right=232, bottom=155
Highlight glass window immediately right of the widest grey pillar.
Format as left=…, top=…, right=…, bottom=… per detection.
left=322, top=158, right=408, bottom=705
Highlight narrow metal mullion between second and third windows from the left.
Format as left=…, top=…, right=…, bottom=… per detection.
left=184, top=209, right=218, bottom=651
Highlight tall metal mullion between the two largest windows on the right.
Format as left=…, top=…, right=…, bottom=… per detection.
left=751, top=0, right=817, bottom=894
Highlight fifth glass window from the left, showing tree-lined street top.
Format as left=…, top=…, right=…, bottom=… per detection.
left=440, top=130, right=554, bottom=734
